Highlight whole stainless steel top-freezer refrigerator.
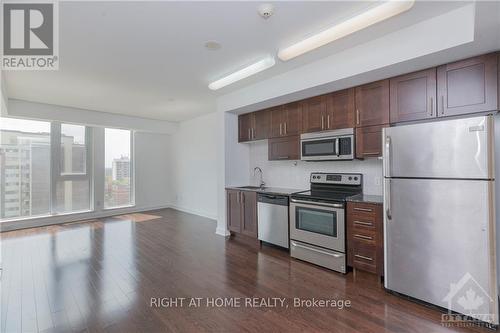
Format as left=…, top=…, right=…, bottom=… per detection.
left=383, top=116, right=500, bottom=324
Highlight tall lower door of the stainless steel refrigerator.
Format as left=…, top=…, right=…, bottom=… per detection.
left=384, top=179, right=498, bottom=323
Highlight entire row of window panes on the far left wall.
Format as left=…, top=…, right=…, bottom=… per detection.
left=0, top=117, right=134, bottom=222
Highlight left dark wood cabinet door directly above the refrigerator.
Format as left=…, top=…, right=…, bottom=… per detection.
left=390, top=68, right=437, bottom=123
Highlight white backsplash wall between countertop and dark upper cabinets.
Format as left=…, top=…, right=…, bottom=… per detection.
left=247, top=140, right=382, bottom=195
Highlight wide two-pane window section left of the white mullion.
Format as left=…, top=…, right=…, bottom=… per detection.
left=0, top=117, right=92, bottom=220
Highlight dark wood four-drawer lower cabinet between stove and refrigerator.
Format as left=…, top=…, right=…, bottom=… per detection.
left=347, top=202, right=384, bottom=276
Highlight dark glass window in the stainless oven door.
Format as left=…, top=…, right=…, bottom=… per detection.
left=295, top=207, right=337, bottom=237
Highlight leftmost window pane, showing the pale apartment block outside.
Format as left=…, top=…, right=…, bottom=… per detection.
left=0, top=118, right=51, bottom=219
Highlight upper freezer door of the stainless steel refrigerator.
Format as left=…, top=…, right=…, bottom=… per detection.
left=383, top=116, right=494, bottom=179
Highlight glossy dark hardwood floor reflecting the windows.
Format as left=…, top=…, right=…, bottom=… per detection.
left=0, top=209, right=496, bottom=332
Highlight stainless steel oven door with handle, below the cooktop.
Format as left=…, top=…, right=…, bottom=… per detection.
left=290, top=199, right=345, bottom=253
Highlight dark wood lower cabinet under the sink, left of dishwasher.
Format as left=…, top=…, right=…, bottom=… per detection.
left=226, top=189, right=257, bottom=239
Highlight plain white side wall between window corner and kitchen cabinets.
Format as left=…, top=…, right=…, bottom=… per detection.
left=170, top=113, right=218, bottom=219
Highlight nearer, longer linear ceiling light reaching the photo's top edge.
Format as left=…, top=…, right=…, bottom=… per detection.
left=278, top=0, right=415, bottom=61
